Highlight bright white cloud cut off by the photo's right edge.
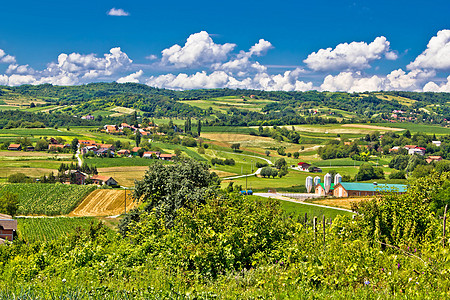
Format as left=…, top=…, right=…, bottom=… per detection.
left=407, top=30, right=450, bottom=70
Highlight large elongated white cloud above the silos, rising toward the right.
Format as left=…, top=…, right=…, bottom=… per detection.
left=303, top=36, right=397, bottom=71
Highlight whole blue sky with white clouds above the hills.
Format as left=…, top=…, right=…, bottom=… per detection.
left=0, top=0, right=450, bottom=92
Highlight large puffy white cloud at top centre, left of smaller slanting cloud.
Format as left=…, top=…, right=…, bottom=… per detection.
left=161, top=31, right=236, bottom=68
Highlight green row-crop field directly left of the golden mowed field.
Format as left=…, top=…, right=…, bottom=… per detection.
left=0, top=183, right=96, bottom=216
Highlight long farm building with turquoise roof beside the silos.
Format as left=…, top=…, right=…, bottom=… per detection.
left=333, top=182, right=407, bottom=197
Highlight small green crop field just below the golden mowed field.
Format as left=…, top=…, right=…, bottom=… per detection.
left=17, top=217, right=98, bottom=243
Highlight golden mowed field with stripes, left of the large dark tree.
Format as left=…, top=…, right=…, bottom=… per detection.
left=69, top=189, right=137, bottom=217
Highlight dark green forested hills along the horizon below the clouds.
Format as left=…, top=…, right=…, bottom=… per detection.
left=2, top=83, right=450, bottom=126
